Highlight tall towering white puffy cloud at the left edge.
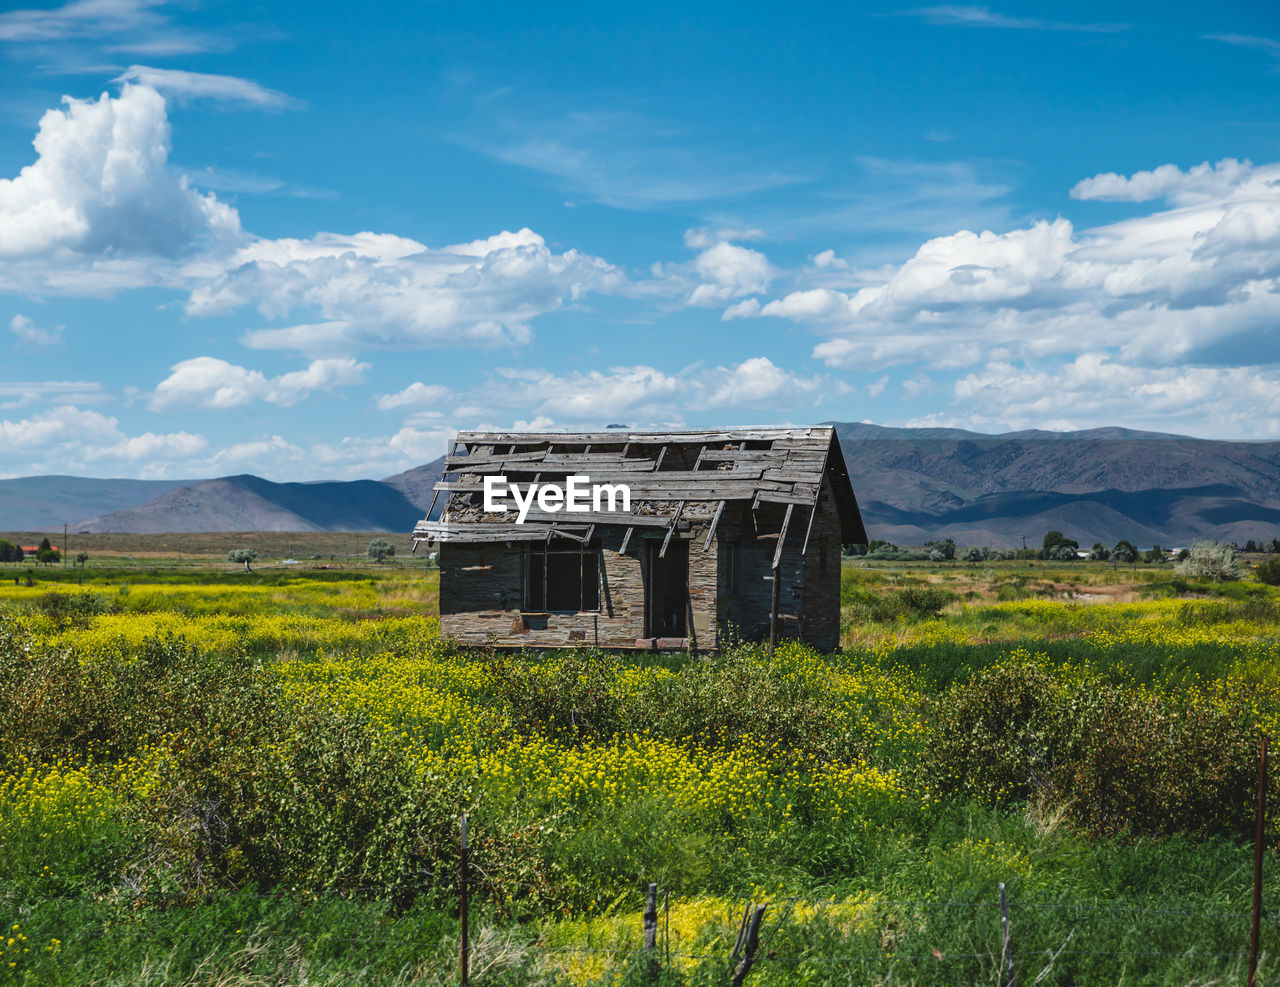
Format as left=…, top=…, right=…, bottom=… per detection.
left=0, top=84, right=239, bottom=260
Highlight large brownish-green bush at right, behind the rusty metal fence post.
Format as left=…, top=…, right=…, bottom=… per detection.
left=918, top=659, right=1257, bottom=837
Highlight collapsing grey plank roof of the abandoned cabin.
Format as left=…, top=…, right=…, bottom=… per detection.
left=413, top=425, right=867, bottom=552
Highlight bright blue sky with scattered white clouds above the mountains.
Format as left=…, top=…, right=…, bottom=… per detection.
left=0, top=0, right=1280, bottom=479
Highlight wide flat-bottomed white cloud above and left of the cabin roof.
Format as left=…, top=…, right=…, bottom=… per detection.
left=187, top=229, right=626, bottom=352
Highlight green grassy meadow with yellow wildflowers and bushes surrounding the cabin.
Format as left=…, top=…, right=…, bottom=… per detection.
left=0, top=560, right=1280, bottom=984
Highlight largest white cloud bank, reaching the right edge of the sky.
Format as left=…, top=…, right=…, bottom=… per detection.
left=736, top=161, right=1280, bottom=370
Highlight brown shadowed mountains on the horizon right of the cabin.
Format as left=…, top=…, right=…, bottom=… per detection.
left=831, top=422, right=1280, bottom=547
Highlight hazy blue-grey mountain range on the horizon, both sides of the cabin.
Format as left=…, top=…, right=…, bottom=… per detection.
left=0, top=422, right=1280, bottom=548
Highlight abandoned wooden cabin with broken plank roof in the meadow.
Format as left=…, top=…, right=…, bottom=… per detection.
left=413, top=426, right=867, bottom=649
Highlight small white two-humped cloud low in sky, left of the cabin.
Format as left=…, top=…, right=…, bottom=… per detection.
left=150, top=356, right=369, bottom=411
